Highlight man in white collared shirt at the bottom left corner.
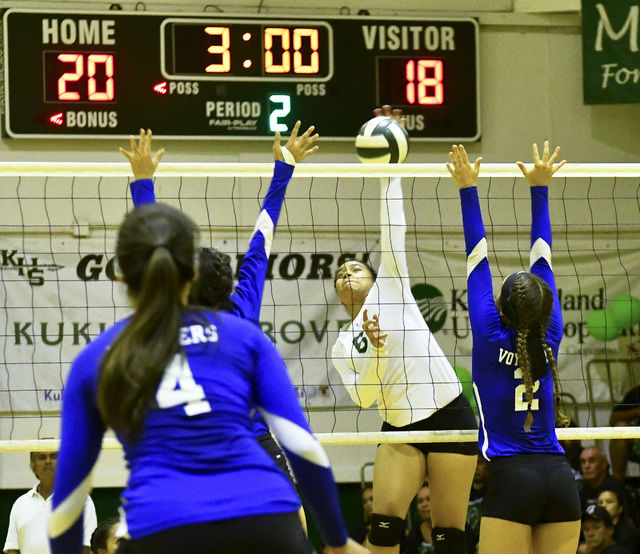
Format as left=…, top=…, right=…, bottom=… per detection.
left=4, top=452, right=97, bottom=554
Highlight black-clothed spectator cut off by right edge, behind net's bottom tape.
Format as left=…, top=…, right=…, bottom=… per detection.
left=609, top=386, right=640, bottom=483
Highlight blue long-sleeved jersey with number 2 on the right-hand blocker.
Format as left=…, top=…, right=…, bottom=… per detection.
left=460, top=186, right=563, bottom=460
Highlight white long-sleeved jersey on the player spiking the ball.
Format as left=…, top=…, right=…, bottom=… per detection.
left=332, top=178, right=462, bottom=427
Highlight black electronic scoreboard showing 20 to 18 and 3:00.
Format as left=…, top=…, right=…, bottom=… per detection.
left=3, top=9, right=480, bottom=141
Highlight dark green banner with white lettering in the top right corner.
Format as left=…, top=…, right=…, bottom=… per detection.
left=582, top=0, right=640, bottom=104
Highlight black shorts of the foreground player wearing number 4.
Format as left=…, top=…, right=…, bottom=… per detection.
left=116, top=512, right=314, bottom=554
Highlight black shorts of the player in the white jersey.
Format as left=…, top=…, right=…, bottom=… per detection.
left=382, top=394, right=478, bottom=456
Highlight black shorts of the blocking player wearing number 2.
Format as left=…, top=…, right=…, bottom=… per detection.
left=482, top=454, right=582, bottom=525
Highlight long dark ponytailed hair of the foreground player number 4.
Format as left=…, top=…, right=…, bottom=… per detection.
left=98, top=204, right=197, bottom=441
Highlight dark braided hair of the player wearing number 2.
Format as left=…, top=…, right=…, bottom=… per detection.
left=501, top=271, right=568, bottom=431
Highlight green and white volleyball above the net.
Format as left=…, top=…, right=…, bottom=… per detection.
left=356, top=116, right=409, bottom=163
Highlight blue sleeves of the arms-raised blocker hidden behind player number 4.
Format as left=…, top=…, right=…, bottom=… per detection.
left=131, top=161, right=294, bottom=436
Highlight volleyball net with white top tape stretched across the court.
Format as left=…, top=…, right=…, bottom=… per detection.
left=0, top=163, right=640, bottom=452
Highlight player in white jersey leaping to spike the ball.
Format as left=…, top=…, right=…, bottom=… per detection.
left=332, top=107, right=477, bottom=554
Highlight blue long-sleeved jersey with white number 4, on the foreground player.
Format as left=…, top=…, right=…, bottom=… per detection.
left=50, top=312, right=347, bottom=554
